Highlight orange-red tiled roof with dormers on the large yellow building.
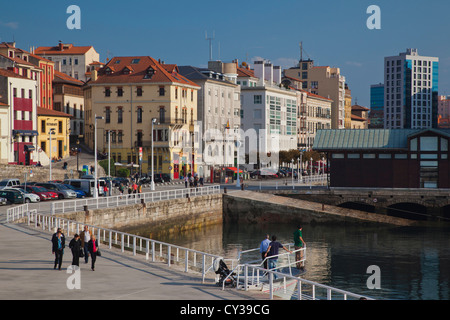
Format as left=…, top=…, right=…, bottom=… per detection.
left=89, top=56, right=199, bottom=87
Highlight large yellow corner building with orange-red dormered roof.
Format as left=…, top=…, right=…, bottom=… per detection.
left=84, top=56, right=201, bottom=179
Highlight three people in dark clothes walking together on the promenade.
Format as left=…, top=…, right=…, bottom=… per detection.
left=52, top=226, right=100, bottom=271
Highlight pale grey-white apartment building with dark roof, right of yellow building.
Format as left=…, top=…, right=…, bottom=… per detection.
left=179, top=61, right=241, bottom=180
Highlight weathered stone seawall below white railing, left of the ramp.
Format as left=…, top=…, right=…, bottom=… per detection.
left=58, top=194, right=223, bottom=238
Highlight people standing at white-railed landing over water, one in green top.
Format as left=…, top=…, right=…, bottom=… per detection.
left=259, top=226, right=306, bottom=279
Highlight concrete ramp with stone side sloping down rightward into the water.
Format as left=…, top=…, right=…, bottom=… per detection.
left=223, top=191, right=417, bottom=226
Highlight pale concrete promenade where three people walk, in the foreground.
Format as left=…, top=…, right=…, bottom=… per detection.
left=0, top=224, right=260, bottom=300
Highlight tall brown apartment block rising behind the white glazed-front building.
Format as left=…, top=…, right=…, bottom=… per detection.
left=284, top=59, right=345, bottom=129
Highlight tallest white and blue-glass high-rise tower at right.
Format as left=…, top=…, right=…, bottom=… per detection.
left=384, top=49, right=439, bottom=129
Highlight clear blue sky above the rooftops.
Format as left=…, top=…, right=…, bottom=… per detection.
left=0, top=0, right=450, bottom=106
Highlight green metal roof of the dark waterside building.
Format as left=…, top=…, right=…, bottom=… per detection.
left=313, top=129, right=449, bottom=151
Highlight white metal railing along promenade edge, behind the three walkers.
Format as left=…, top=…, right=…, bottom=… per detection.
left=11, top=210, right=223, bottom=282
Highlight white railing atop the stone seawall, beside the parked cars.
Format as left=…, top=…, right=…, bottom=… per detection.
left=51, top=185, right=221, bottom=214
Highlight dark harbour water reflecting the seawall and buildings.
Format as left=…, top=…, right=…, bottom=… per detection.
left=123, top=224, right=450, bottom=300
